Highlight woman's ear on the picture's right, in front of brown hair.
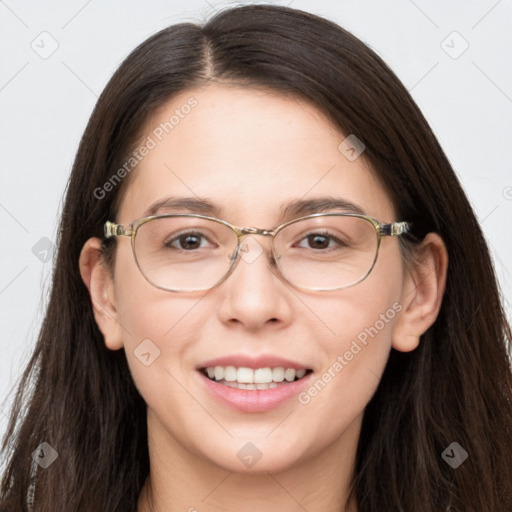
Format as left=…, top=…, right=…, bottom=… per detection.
left=392, top=233, right=448, bottom=352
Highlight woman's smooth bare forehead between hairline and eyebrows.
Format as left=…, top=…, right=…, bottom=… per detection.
left=117, top=84, right=393, bottom=226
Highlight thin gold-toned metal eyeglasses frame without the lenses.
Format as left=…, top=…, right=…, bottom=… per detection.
left=104, top=212, right=412, bottom=293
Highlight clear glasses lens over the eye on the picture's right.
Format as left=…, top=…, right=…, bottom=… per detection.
left=275, top=215, right=378, bottom=290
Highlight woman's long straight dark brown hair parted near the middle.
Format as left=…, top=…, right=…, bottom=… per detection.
left=0, top=5, right=512, bottom=512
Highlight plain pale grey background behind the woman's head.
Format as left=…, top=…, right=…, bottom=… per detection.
left=0, top=0, right=512, bottom=440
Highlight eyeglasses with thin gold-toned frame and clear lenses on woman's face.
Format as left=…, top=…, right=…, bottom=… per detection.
left=104, top=213, right=411, bottom=292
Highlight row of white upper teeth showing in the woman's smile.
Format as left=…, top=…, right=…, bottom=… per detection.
left=206, top=366, right=306, bottom=389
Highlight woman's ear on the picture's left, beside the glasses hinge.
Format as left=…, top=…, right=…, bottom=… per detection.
left=79, top=238, right=123, bottom=350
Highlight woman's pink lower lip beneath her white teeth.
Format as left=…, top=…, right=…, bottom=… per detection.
left=198, top=371, right=313, bottom=412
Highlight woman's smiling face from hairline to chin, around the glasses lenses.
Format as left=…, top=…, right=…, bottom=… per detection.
left=106, top=85, right=407, bottom=472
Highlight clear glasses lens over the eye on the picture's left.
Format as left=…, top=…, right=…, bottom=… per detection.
left=134, top=217, right=238, bottom=291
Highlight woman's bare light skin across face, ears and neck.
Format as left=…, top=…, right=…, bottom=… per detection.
left=80, top=84, right=447, bottom=512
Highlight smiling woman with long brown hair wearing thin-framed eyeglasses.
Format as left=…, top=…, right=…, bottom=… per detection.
left=0, top=5, right=512, bottom=512
